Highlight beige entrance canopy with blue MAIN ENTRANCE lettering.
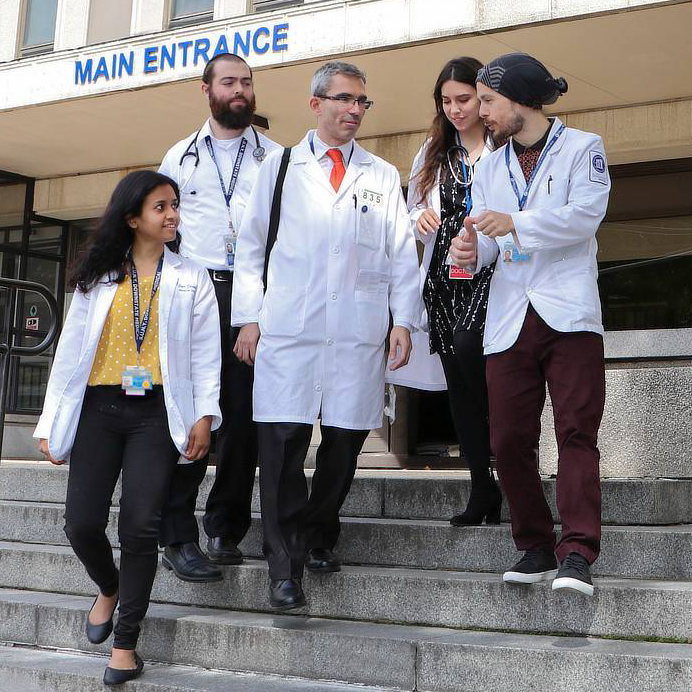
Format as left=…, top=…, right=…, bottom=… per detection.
left=0, top=0, right=692, bottom=178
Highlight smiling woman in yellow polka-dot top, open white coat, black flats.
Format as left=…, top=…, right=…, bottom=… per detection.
left=34, top=171, right=221, bottom=685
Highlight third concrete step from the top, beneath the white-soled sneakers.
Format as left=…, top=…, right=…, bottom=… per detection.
left=0, top=543, right=692, bottom=641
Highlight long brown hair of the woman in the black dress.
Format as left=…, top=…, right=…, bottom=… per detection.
left=414, top=57, right=483, bottom=202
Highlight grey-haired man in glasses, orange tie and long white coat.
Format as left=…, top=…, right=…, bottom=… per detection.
left=231, top=62, right=421, bottom=610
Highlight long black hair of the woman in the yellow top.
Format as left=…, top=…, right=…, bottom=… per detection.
left=70, top=171, right=180, bottom=293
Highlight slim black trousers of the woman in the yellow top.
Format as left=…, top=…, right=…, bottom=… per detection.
left=65, top=386, right=179, bottom=649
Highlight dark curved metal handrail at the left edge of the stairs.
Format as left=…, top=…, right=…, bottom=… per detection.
left=0, top=277, right=58, bottom=457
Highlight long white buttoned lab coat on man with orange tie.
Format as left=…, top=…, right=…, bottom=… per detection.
left=231, top=136, right=420, bottom=430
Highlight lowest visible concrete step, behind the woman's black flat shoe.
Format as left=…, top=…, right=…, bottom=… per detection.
left=0, top=645, right=384, bottom=692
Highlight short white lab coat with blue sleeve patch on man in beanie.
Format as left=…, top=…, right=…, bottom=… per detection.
left=471, top=118, right=610, bottom=354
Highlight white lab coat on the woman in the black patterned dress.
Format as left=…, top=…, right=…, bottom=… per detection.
left=386, top=140, right=492, bottom=391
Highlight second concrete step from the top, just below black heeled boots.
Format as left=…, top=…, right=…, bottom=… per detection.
left=0, top=501, right=692, bottom=579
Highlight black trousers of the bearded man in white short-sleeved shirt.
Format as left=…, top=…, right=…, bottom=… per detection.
left=160, top=280, right=257, bottom=546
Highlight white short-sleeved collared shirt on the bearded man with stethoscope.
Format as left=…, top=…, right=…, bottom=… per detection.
left=159, top=120, right=280, bottom=270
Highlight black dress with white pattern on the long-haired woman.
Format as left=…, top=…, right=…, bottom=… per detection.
left=423, top=153, right=495, bottom=355
